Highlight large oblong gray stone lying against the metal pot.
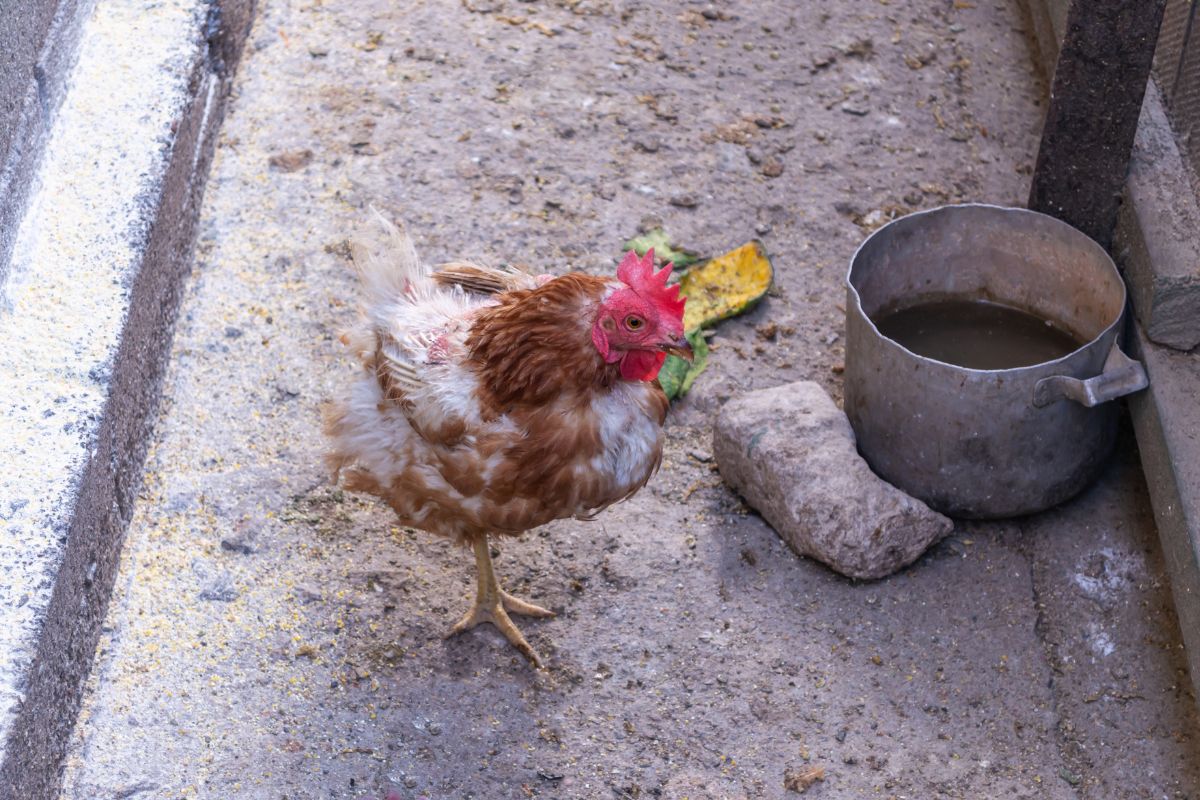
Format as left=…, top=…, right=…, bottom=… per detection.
left=713, top=381, right=954, bottom=578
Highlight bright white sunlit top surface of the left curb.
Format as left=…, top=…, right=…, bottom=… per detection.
left=0, top=0, right=207, bottom=753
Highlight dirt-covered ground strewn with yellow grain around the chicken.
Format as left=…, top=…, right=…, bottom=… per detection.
left=64, top=0, right=1200, bottom=800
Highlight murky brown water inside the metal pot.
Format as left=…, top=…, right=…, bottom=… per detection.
left=871, top=299, right=1085, bottom=369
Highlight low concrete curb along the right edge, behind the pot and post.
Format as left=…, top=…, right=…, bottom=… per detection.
left=1026, top=0, right=1200, bottom=697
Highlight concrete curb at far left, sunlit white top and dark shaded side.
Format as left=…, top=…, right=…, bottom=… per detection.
left=0, top=0, right=253, bottom=800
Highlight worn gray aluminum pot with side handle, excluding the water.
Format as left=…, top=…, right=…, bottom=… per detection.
left=845, top=205, right=1146, bottom=518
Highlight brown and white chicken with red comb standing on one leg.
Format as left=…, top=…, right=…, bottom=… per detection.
left=325, top=213, right=691, bottom=667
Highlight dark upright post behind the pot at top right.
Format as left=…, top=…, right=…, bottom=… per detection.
left=1030, top=0, right=1166, bottom=247
